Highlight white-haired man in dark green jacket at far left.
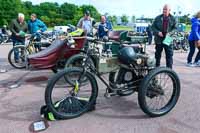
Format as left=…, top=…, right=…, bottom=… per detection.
left=10, top=13, right=28, bottom=63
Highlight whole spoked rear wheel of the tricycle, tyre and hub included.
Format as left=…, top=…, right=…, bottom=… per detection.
left=138, top=67, right=180, bottom=117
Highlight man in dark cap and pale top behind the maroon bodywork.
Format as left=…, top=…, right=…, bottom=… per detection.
left=77, top=11, right=94, bottom=35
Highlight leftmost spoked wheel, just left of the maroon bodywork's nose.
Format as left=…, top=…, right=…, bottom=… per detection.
left=8, top=46, right=26, bottom=69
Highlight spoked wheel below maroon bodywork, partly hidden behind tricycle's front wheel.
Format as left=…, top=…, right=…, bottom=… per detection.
left=65, top=54, right=95, bottom=84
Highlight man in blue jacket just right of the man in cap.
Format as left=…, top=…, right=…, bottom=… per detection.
left=98, top=16, right=112, bottom=38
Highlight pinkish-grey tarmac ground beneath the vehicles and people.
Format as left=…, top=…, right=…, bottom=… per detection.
left=0, top=45, right=200, bottom=133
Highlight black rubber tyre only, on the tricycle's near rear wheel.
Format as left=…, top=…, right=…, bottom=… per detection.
left=138, top=67, right=181, bottom=117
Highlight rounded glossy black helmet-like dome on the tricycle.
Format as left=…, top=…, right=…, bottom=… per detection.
left=118, top=47, right=136, bottom=64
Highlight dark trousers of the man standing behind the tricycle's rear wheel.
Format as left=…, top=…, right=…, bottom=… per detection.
left=155, top=44, right=173, bottom=68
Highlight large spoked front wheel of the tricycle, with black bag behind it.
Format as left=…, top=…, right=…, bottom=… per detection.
left=45, top=67, right=98, bottom=119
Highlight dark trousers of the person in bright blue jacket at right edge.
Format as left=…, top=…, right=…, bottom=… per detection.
left=187, top=41, right=200, bottom=63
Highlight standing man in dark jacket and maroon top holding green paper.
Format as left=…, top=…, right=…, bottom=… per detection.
left=152, top=4, right=176, bottom=68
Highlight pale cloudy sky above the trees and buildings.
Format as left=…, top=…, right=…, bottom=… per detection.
left=23, top=0, right=200, bottom=17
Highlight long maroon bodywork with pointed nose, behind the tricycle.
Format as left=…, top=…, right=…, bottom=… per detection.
left=28, top=37, right=86, bottom=69
